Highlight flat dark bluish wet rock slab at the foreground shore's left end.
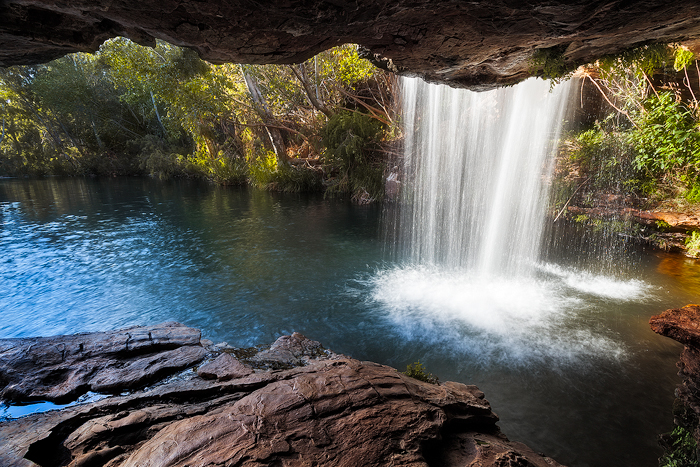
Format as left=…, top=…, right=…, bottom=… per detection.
left=0, top=323, right=207, bottom=402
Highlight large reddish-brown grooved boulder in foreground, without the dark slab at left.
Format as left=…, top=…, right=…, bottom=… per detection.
left=0, top=326, right=560, bottom=467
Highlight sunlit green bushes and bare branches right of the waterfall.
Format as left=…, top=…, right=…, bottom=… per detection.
left=556, top=45, right=700, bottom=202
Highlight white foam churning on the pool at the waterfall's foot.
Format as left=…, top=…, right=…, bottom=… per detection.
left=370, top=266, right=625, bottom=366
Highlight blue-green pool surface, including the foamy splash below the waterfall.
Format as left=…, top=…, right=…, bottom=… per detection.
left=0, top=179, right=700, bottom=467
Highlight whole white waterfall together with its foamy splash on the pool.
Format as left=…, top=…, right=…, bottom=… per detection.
left=372, top=79, right=645, bottom=365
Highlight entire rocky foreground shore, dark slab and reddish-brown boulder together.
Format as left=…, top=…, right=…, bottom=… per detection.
left=0, top=323, right=560, bottom=467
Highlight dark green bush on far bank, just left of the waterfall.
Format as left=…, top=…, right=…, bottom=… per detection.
left=322, top=111, right=384, bottom=199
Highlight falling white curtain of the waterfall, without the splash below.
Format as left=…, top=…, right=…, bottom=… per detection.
left=399, top=78, right=568, bottom=277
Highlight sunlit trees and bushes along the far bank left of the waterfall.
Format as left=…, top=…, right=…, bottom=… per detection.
left=0, top=38, right=393, bottom=201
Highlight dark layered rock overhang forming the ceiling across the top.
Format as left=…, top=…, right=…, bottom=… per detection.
left=0, top=0, right=700, bottom=89
